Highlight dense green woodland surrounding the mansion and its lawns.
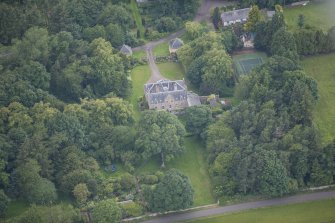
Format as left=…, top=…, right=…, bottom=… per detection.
left=0, top=0, right=335, bottom=223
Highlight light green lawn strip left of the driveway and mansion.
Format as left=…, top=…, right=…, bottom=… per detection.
left=129, top=65, right=150, bottom=120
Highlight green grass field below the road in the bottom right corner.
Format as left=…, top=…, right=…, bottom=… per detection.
left=188, top=199, right=335, bottom=223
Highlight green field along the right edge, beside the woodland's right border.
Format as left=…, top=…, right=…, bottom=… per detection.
left=302, top=53, right=335, bottom=143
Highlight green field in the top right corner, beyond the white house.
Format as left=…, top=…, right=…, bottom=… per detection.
left=284, top=0, right=335, bottom=31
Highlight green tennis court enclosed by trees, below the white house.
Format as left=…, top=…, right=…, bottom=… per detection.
left=233, top=52, right=267, bottom=75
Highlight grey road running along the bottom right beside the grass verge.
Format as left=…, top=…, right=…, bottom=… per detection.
left=143, top=191, right=335, bottom=223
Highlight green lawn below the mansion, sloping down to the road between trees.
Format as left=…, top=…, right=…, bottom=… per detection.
left=137, top=137, right=214, bottom=206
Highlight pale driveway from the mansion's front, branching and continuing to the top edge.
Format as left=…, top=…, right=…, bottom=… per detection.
left=132, top=0, right=234, bottom=83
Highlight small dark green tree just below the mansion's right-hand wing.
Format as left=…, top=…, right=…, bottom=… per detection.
left=185, top=105, right=213, bottom=136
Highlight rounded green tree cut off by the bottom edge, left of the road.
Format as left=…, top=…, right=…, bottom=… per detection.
left=92, top=199, right=122, bottom=223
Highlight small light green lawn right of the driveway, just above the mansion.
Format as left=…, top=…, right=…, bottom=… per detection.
left=157, top=62, right=184, bottom=80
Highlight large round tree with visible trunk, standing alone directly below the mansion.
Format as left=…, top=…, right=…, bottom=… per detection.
left=135, top=110, right=185, bottom=167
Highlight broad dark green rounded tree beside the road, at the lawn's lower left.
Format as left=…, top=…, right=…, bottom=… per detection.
left=146, top=169, right=194, bottom=212
